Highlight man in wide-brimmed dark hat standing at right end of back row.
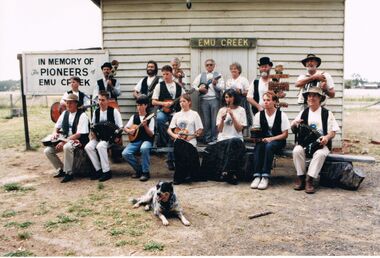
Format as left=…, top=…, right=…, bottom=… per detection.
left=295, top=54, right=335, bottom=110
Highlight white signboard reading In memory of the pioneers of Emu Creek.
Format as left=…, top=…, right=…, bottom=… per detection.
left=22, top=50, right=109, bottom=95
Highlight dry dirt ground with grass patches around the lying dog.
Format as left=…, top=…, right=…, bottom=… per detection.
left=0, top=146, right=380, bottom=256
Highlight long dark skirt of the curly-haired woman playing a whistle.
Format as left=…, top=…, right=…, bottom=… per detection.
left=201, top=138, right=245, bottom=181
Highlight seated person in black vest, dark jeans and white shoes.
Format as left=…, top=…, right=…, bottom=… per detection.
left=251, top=91, right=290, bottom=190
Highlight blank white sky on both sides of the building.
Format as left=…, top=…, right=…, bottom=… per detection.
left=0, top=0, right=380, bottom=81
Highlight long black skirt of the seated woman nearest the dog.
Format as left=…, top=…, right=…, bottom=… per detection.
left=174, top=139, right=205, bottom=183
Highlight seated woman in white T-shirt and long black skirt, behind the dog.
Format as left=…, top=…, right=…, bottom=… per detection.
left=168, top=94, right=203, bottom=184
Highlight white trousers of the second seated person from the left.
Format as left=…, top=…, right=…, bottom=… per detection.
left=84, top=139, right=110, bottom=173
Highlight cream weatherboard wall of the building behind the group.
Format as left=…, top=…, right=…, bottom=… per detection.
left=101, top=0, right=345, bottom=145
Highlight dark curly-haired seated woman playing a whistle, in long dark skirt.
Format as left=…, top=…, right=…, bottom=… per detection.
left=202, top=89, right=247, bottom=184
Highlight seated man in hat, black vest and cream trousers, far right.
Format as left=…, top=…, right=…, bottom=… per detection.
left=291, top=87, right=340, bottom=194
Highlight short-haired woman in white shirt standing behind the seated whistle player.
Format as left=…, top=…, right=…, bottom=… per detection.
left=226, top=62, right=252, bottom=128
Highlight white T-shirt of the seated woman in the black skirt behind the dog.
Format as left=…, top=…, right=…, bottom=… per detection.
left=169, top=109, right=203, bottom=147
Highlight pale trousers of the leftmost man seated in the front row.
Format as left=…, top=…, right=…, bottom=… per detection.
left=44, top=141, right=76, bottom=175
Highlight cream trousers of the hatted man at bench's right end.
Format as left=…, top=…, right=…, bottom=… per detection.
left=293, top=145, right=330, bottom=178
